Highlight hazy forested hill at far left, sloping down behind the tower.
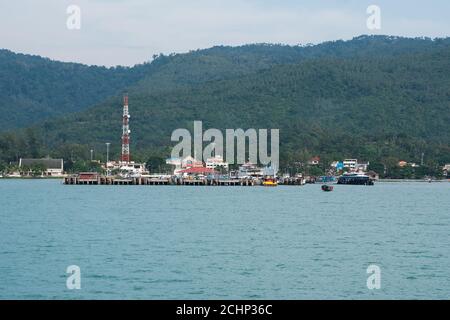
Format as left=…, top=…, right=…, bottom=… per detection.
left=0, top=50, right=152, bottom=131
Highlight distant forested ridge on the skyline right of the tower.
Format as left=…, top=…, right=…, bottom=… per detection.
left=125, top=36, right=450, bottom=94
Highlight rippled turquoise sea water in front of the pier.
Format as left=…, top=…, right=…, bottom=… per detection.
left=0, top=180, right=450, bottom=299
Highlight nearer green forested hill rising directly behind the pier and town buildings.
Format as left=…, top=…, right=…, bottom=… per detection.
left=14, top=42, right=450, bottom=168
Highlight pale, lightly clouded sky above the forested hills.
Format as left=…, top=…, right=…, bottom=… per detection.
left=0, top=0, right=450, bottom=66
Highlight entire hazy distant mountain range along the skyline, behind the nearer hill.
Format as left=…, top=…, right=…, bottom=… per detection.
left=0, top=36, right=450, bottom=131
